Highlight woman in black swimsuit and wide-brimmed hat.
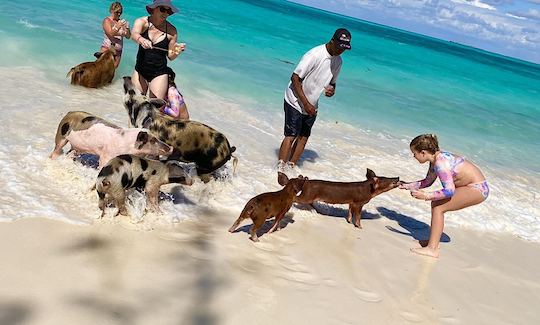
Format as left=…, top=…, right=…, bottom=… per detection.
left=131, top=0, right=185, bottom=99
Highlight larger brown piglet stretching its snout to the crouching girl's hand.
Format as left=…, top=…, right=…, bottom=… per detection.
left=288, top=168, right=400, bottom=228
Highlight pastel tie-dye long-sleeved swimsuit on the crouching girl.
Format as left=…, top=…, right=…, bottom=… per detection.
left=406, top=151, right=489, bottom=201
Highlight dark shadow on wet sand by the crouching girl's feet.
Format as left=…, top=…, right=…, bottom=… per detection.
left=377, top=207, right=450, bottom=246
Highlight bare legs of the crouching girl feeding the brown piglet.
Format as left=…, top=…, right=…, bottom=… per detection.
left=411, top=186, right=485, bottom=257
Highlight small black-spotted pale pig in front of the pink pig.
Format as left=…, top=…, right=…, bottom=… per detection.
left=96, top=155, right=193, bottom=217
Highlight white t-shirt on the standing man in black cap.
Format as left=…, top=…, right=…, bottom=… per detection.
left=285, top=44, right=342, bottom=115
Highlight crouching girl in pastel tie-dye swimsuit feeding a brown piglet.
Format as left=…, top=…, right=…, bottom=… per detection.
left=400, top=134, right=489, bottom=257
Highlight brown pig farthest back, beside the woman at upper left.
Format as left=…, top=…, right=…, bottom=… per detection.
left=66, top=47, right=116, bottom=88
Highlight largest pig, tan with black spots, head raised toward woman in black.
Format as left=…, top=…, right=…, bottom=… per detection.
left=124, top=77, right=238, bottom=181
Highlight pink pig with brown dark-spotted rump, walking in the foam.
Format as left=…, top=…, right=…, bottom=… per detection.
left=50, top=112, right=172, bottom=168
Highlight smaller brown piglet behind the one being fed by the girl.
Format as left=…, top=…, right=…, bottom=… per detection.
left=229, top=175, right=307, bottom=241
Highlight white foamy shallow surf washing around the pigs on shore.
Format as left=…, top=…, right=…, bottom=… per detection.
left=0, top=68, right=540, bottom=241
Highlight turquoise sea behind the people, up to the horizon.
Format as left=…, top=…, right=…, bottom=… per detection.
left=0, top=0, right=540, bottom=176
